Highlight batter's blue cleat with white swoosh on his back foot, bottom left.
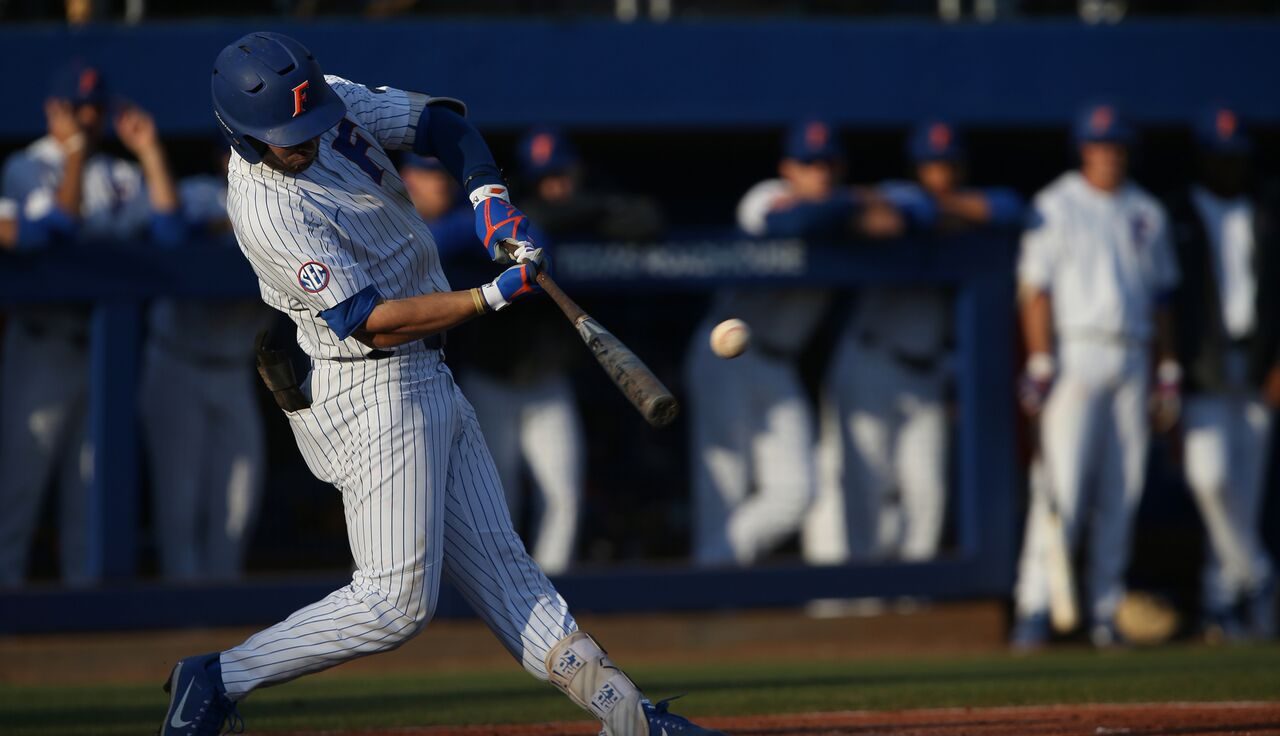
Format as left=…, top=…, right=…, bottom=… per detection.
left=156, top=652, right=244, bottom=736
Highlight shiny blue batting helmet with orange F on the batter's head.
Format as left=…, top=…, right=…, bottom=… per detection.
left=212, top=33, right=347, bottom=164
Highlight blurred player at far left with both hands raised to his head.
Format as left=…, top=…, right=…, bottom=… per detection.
left=0, top=61, right=180, bottom=586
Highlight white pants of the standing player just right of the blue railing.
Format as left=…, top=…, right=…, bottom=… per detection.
left=1015, top=337, right=1151, bottom=623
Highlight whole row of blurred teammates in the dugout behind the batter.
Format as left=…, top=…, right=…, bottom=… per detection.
left=0, top=64, right=1280, bottom=648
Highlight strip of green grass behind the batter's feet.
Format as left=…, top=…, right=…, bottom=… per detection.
left=0, top=645, right=1280, bottom=736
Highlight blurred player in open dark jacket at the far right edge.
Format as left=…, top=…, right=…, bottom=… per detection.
left=1170, top=108, right=1280, bottom=640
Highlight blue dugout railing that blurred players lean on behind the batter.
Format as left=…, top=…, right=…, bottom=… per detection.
left=0, top=233, right=1016, bottom=632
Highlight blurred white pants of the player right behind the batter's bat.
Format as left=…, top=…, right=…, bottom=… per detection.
left=463, top=370, right=586, bottom=575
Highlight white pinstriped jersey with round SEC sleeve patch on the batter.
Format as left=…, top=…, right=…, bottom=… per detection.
left=227, top=76, right=449, bottom=358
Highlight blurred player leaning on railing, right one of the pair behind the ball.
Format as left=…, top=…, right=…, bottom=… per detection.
left=805, top=120, right=1023, bottom=561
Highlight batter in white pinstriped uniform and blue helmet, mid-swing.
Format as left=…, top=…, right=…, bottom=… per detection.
left=161, top=33, right=716, bottom=736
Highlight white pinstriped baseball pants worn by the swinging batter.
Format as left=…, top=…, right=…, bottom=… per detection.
left=221, top=351, right=577, bottom=700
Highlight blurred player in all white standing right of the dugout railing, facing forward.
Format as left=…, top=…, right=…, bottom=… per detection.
left=1012, top=105, right=1181, bottom=649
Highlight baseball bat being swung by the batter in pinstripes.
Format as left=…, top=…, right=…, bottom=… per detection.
left=538, top=273, right=680, bottom=428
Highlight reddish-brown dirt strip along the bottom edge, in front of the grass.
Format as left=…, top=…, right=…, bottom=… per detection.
left=287, top=703, right=1280, bottom=736
